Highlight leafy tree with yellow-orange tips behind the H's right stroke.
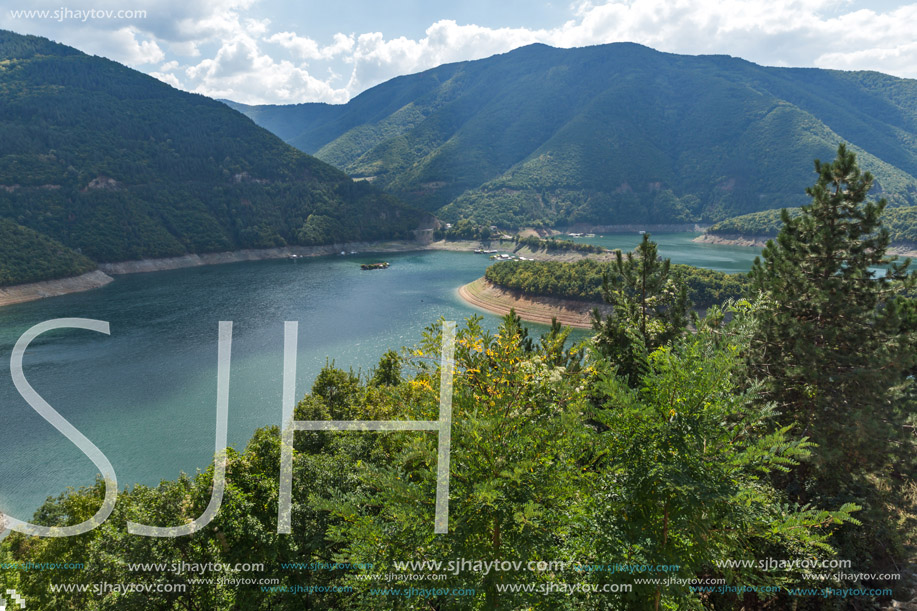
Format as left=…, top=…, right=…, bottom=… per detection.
left=327, top=315, right=588, bottom=609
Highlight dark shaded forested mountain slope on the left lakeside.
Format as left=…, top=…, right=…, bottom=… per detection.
left=0, top=31, right=424, bottom=283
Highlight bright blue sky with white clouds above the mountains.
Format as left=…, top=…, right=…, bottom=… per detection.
left=0, top=0, right=917, bottom=104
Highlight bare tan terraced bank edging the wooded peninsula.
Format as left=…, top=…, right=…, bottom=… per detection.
left=457, top=277, right=608, bottom=329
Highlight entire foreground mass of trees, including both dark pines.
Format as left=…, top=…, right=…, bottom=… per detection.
left=0, top=147, right=917, bottom=611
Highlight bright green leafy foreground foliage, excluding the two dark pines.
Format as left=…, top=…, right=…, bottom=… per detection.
left=0, top=310, right=868, bottom=611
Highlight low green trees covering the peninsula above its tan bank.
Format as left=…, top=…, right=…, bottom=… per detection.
left=484, top=259, right=750, bottom=308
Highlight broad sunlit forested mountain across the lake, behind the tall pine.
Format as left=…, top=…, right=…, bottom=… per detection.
left=232, top=43, right=917, bottom=227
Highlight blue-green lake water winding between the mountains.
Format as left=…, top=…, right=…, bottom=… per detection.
left=0, top=234, right=758, bottom=519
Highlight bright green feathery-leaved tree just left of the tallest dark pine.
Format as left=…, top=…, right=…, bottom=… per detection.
left=579, top=302, right=858, bottom=609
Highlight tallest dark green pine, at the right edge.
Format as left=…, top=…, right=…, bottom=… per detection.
left=751, top=144, right=917, bottom=562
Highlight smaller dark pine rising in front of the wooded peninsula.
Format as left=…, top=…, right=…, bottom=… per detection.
left=592, top=234, right=690, bottom=384
